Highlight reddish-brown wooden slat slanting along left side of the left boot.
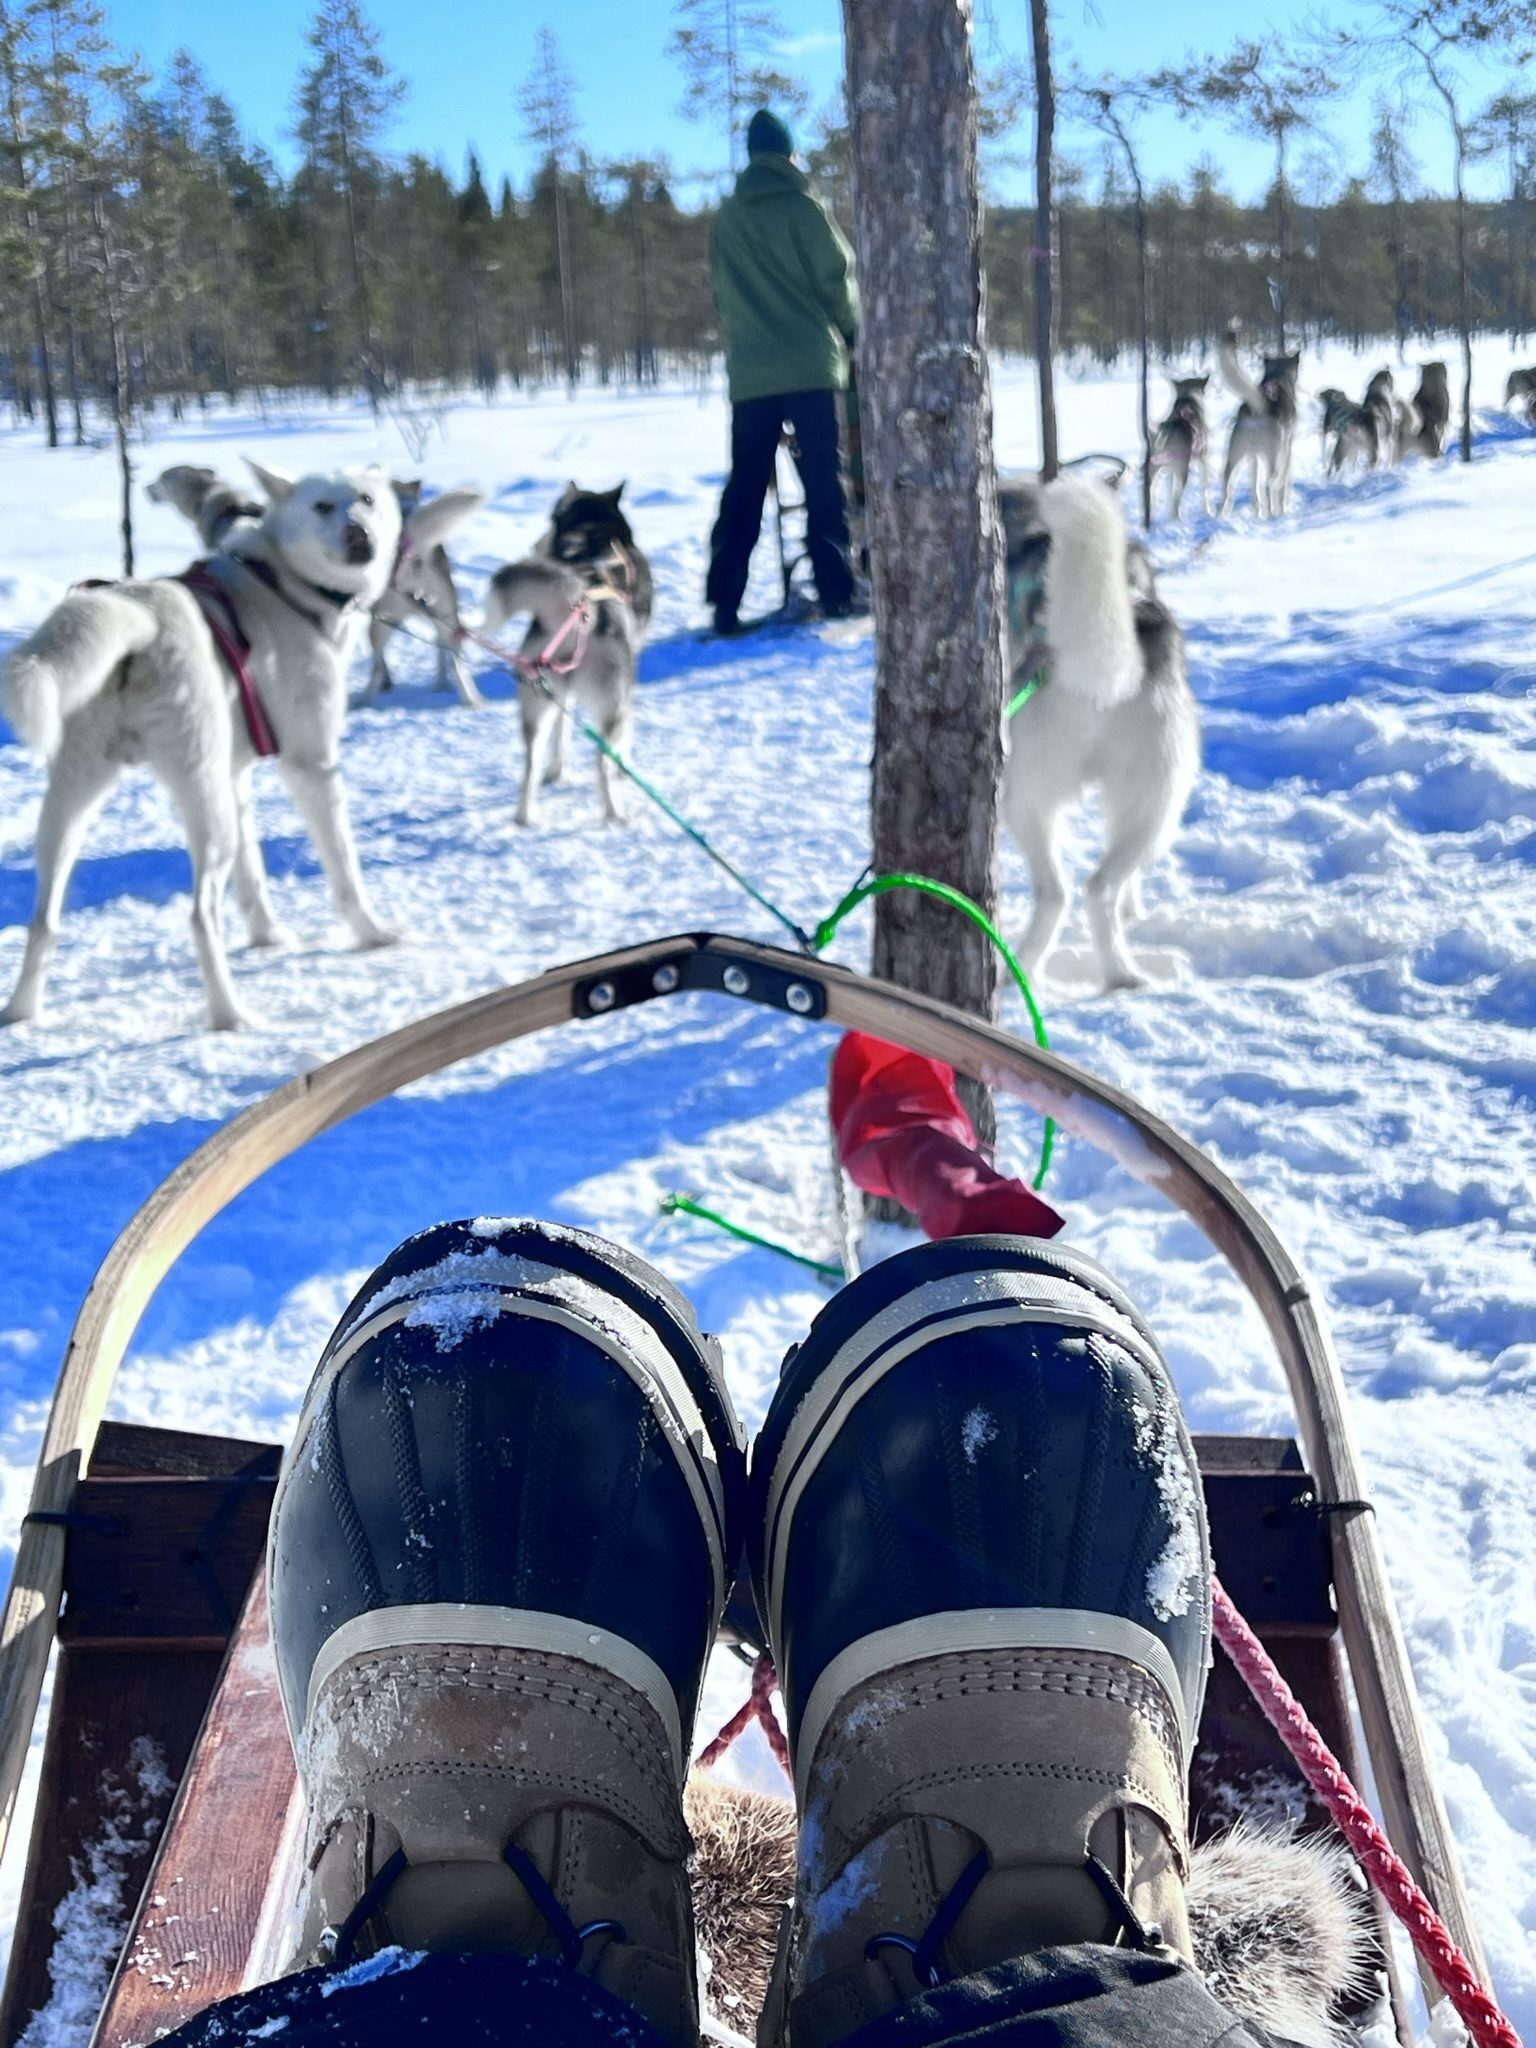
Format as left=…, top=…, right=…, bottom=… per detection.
left=92, top=1573, right=295, bottom=2048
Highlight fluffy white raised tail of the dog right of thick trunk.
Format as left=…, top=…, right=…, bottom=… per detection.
left=1040, top=475, right=1141, bottom=705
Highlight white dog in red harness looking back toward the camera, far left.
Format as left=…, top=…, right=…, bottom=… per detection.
left=0, top=463, right=399, bottom=1030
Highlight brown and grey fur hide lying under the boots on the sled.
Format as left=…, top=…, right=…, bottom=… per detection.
left=686, top=1772, right=1372, bottom=2048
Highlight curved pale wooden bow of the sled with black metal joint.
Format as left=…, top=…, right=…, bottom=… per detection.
left=0, top=934, right=1487, bottom=1999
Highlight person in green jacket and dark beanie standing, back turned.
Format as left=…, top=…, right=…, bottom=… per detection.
left=705, top=109, right=858, bottom=633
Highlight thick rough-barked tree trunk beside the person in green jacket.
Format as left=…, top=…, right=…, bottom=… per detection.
left=844, top=0, right=1006, bottom=1141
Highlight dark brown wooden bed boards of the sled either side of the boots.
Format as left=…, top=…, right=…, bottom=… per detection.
left=0, top=1423, right=1411, bottom=2048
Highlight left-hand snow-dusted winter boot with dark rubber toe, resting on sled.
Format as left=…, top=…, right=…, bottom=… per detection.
left=270, top=1219, right=745, bottom=2048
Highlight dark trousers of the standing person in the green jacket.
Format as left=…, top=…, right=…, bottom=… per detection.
left=705, top=391, right=854, bottom=618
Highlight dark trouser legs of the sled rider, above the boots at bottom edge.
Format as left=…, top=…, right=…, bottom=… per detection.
left=153, top=1946, right=1272, bottom=2048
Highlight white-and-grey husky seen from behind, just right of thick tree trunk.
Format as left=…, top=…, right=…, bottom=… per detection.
left=1001, top=475, right=1200, bottom=989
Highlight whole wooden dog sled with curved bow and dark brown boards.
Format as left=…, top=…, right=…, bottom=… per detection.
left=0, top=934, right=1487, bottom=2048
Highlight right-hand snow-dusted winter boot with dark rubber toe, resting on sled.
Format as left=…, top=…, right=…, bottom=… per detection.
left=748, top=1237, right=1210, bottom=2048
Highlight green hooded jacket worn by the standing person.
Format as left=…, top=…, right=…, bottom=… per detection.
left=709, top=156, right=858, bottom=406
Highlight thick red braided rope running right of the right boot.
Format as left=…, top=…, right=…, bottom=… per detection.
left=1212, top=1581, right=1520, bottom=2048
